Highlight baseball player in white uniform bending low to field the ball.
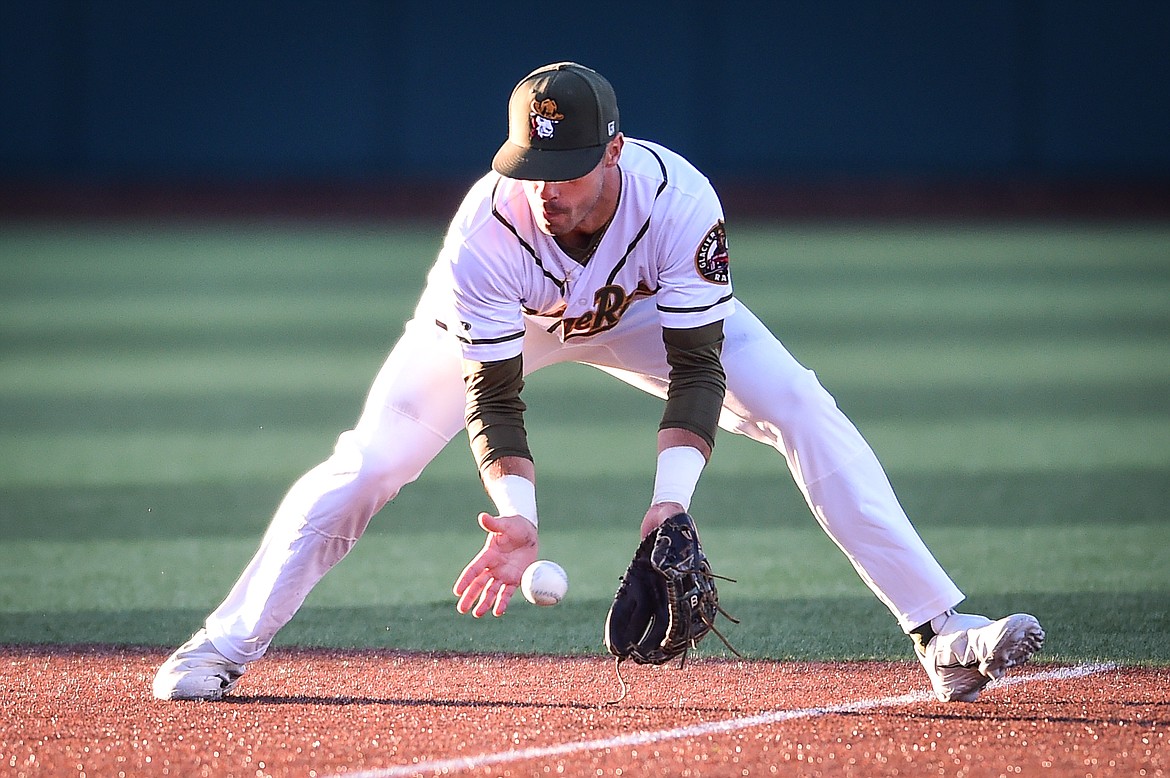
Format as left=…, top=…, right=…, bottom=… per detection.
left=153, top=62, right=1044, bottom=701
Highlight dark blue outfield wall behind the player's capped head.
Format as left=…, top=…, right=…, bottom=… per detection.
left=0, top=0, right=1170, bottom=183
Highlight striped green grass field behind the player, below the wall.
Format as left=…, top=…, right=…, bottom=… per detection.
left=0, top=225, right=1170, bottom=665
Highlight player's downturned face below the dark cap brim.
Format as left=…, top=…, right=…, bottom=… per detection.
left=522, top=136, right=621, bottom=237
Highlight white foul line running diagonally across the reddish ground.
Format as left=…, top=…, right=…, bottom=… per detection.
left=338, top=662, right=1117, bottom=778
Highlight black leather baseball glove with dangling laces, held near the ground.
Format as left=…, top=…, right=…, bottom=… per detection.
left=605, top=514, right=739, bottom=696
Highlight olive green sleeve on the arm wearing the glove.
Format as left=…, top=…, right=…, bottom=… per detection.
left=659, top=321, right=727, bottom=447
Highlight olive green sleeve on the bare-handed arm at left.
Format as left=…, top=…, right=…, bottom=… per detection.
left=463, top=356, right=532, bottom=471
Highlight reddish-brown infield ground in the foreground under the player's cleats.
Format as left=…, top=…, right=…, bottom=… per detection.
left=0, top=647, right=1170, bottom=778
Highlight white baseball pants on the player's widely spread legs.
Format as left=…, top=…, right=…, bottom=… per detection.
left=205, top=298, right=963, bottom=662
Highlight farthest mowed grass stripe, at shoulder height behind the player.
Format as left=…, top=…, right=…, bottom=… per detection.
left=0, top=222, right=1170, bottom=276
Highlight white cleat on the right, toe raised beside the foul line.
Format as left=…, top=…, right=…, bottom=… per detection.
left=915, top=613, right=1044, bottom=702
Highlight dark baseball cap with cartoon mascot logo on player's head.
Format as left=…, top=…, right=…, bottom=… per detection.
left=491, top=62, right=618, bottom=181
